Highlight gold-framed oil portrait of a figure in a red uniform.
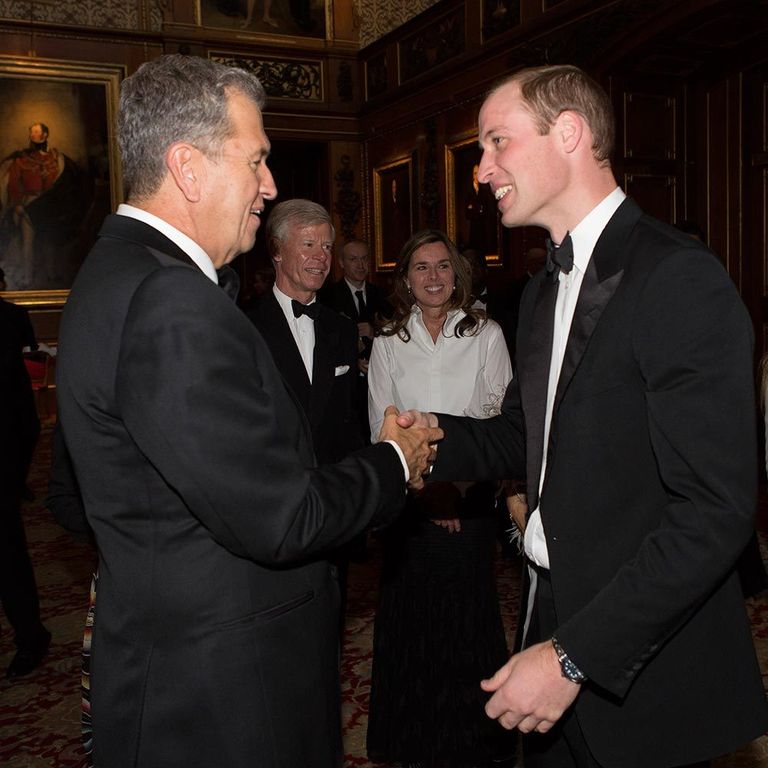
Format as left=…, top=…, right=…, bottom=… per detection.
left=0, top=57, right=125, bottom=304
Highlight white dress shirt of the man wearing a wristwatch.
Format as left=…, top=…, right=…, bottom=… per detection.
left=524, top=187, right=626, bottom=568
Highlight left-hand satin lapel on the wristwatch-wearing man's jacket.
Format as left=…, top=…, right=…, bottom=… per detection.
left=518, top=275, right=558, bottom=509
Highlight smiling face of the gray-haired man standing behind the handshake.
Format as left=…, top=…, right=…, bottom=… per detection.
left=273, top=223, right=333, bottom=304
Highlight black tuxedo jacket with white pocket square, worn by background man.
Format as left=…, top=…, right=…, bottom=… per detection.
left=249, top=291, right=363, bottom=464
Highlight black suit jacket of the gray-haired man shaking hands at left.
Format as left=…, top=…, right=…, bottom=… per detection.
left=57, top=216, right=404, bottom=768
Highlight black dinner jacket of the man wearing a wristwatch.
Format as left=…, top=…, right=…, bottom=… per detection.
left=433, top=200, right=768, bottom=768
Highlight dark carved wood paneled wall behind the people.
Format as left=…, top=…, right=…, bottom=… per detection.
left=0, top=0, right=768, bottom=360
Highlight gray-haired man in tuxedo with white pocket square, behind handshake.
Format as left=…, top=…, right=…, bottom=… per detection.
left=249, top=199, right=365, bottom=632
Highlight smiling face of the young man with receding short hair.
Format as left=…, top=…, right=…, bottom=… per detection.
left=478, top=82, right=568, bottom=229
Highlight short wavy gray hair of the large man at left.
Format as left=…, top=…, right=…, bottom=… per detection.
left=117, top=54, right=266, bottom=201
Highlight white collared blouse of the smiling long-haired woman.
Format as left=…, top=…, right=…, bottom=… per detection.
left=368, top=305, right=512, bottom=442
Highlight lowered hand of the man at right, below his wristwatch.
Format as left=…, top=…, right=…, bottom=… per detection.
left=480, top=641, right=581, bottom=733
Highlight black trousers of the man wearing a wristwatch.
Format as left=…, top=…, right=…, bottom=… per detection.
left=523, top=568, right=710, bottom=768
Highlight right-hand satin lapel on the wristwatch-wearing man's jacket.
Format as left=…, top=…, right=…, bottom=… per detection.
left=552, top=198, right=642, bottom=414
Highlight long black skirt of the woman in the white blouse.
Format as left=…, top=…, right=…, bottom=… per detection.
left=367, top=486, right=512, bottom=768
